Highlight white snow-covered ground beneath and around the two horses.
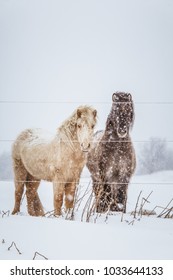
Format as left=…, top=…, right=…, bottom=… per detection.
left=0, top=166, right=173, bottom=260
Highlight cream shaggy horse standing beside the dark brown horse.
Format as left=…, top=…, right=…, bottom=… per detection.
left=12, top=106, right=97, bottom=216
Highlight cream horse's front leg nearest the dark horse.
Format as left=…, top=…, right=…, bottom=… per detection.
left=65, top=182, right=76, bottom=210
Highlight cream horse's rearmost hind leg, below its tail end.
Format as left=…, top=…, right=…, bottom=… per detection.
left=12, top=159, right=27, bottom=215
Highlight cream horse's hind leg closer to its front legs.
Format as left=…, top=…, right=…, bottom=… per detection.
left=26, top=174, right=44, bottom=216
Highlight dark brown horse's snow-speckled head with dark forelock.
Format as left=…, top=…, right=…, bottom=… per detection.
left=107, top=92, right=134, bottom=138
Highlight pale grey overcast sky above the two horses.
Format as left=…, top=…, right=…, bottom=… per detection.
left=0, top=0, right=173, bottom=153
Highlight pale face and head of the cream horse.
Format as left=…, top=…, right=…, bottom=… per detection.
left=76, top=106, right=97, bottom=152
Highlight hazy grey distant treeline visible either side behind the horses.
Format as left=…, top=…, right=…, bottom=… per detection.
left=0, top=138, right=173, bottom=181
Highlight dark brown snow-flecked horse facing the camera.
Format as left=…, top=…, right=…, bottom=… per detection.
left=87, top=92, right=136, bottom=213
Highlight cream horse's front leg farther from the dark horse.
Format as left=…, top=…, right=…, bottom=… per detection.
left=53, top=176, right=64, bottom=216
